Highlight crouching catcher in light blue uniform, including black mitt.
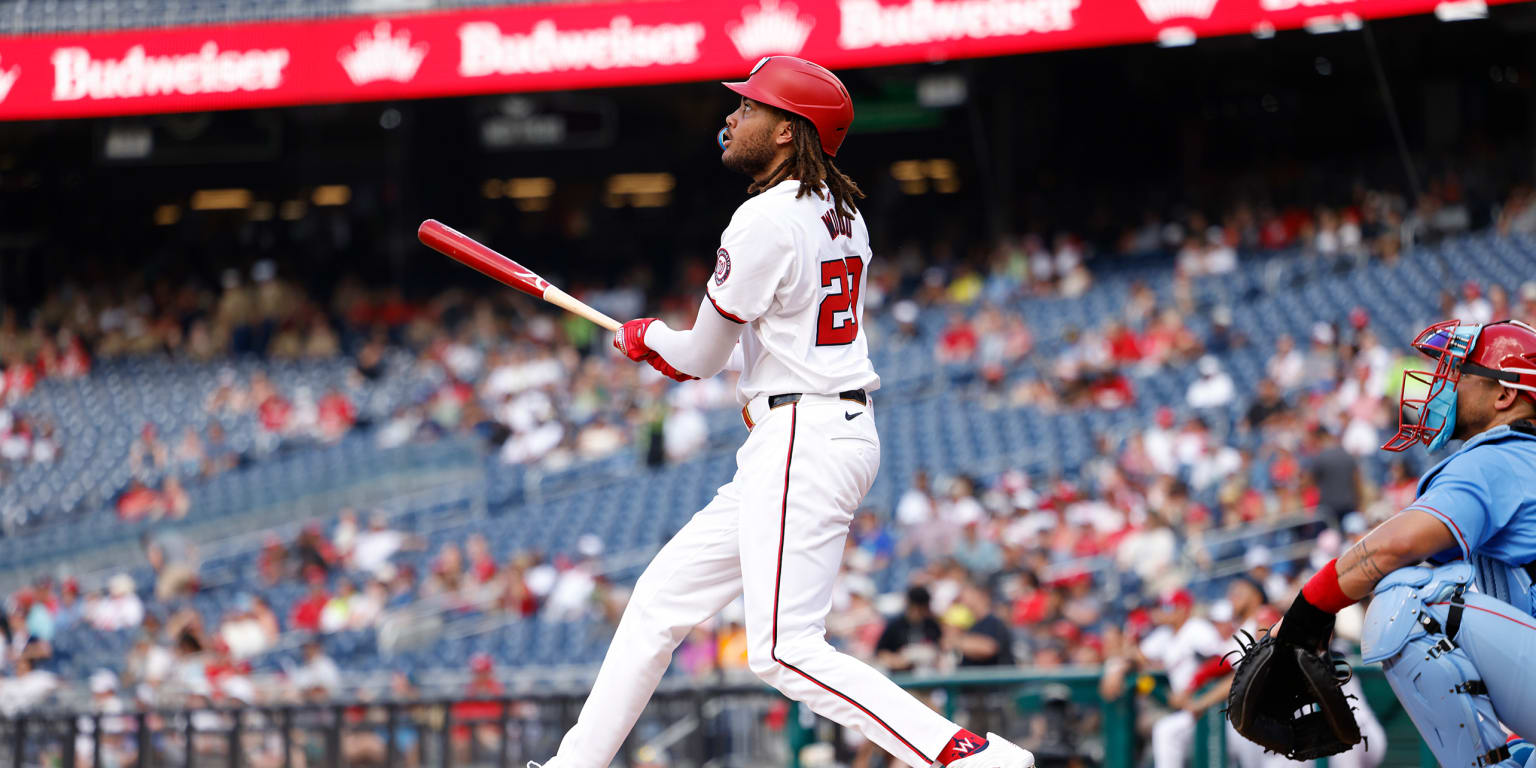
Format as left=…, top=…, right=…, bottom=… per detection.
left=1227, top=319, right=1536, bottom=768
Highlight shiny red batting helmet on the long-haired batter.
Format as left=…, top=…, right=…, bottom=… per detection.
left=722, top=55, right=854, bottom=157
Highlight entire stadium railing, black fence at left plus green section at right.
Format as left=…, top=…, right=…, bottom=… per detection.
left=9, top=665, right=1435, bottom=768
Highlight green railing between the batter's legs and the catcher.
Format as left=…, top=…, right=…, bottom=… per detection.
left=788, top=665, right=1436, bottom=768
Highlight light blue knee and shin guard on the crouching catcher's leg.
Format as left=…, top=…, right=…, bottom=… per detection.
left=1361, top=562, right=1510, bottom=768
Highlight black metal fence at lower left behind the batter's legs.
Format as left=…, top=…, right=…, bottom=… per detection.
left=0, top=685, right=790, bottom=768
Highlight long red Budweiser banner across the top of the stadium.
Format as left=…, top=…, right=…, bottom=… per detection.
left=0, top=0, right=1504, bottom=120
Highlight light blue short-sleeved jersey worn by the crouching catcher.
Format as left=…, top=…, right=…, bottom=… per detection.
left=1407, top=427, right=1536, bottom=567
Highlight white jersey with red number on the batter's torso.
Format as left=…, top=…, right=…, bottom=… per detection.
left=705, top=178, right=880, bottom=404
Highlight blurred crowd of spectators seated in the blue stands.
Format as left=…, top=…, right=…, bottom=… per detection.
left=0, top=172, right=1536, bottom=765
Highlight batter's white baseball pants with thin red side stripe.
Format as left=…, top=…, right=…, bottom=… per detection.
left=548, top=395, right=958, bottom=768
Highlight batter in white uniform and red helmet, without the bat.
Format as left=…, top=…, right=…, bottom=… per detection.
left=530, top=57, right=1034, bottom=768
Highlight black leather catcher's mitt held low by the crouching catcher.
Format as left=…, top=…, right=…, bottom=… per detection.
left=1227, top=631, right=1359, bottom=760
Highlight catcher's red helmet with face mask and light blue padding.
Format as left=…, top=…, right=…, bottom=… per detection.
left=1382, top=319, right=1536, bottom=450
